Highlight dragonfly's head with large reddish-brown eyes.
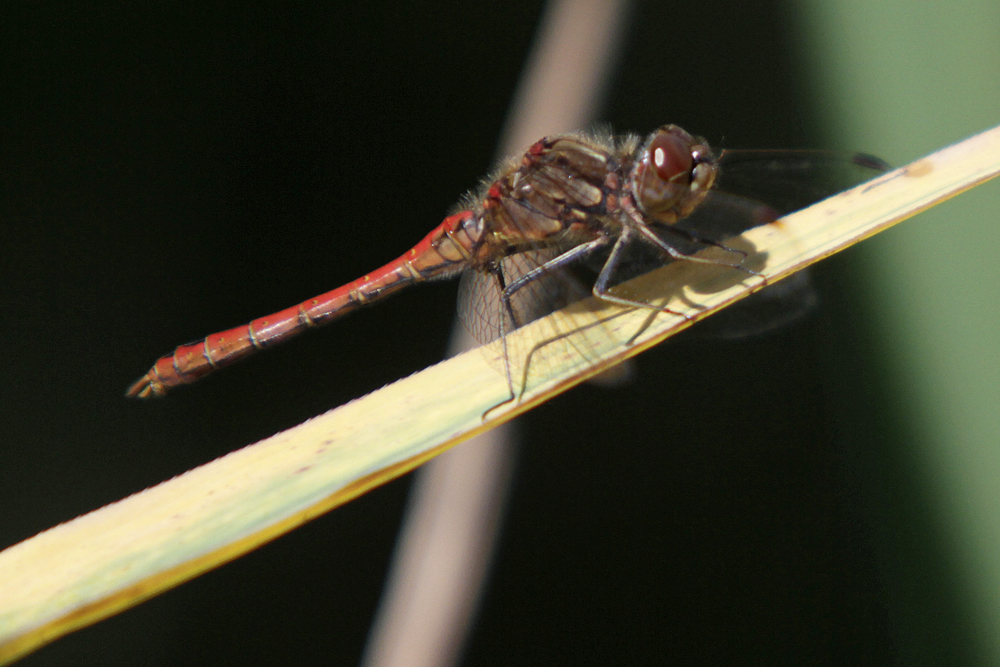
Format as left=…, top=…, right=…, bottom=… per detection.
left=629, top=125, right=718, bottom=225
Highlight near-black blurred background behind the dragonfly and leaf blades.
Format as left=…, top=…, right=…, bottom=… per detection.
left=0, top=0, right=971, bottom=665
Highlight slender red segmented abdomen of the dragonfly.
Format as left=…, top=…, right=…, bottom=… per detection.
left=126, top=211, right=483, bottom=398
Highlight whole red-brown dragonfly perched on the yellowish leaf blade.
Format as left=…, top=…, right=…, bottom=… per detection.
left=126, top=125, right=882, bottom=400
